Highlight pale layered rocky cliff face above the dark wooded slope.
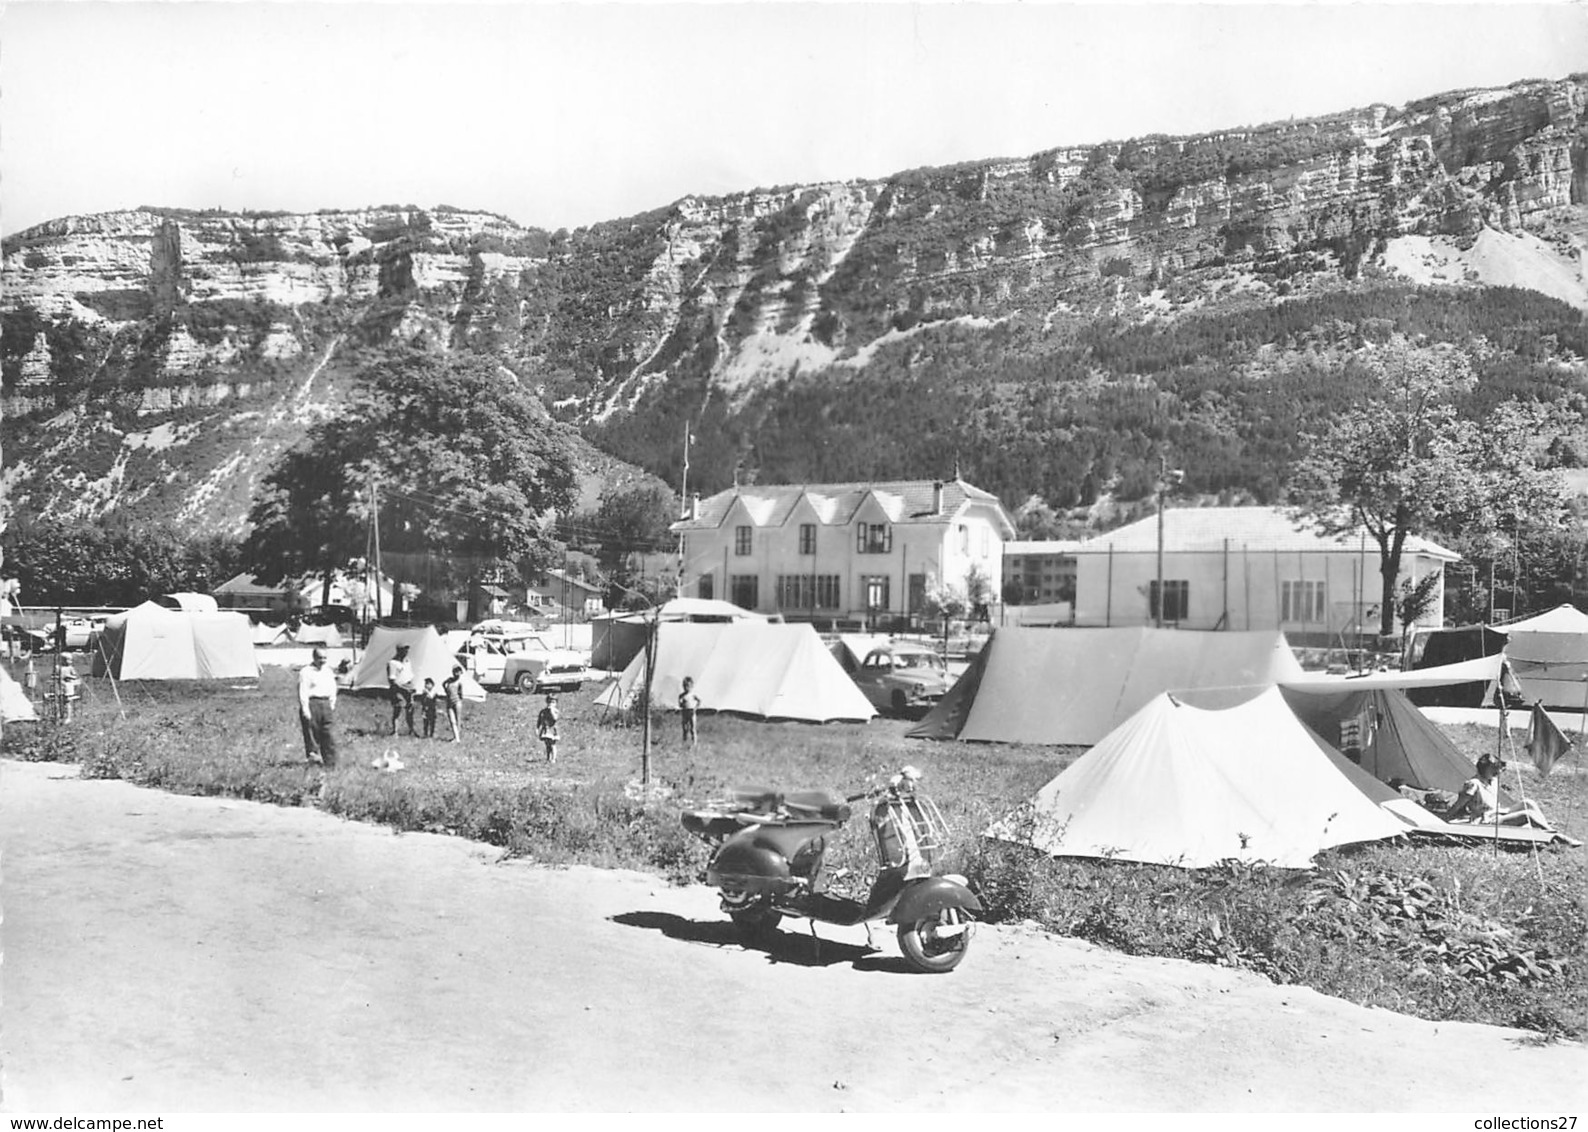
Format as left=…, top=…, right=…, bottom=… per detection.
left=9, top=76, right=1588, bottom=527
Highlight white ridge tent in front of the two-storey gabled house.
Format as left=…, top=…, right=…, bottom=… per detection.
left=596, top=621, right=877, bottom=722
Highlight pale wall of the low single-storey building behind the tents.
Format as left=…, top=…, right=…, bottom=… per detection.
left=1075, top=546, right=1443, bottom=635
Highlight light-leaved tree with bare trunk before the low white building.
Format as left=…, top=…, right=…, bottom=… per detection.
left=1289, top=341, right=1569, bottom=635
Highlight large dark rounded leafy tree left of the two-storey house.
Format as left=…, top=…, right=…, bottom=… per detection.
left=245, top=351, right=575, bottom=600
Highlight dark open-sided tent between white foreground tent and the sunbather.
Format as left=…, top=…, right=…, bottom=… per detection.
left=1282, top=681, right=1509, bottom=805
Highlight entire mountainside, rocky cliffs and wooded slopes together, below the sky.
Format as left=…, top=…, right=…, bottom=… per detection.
left=0, top=76, right=1588, bottom=535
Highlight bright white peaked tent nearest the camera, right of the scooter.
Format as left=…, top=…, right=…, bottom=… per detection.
left=991, top=687, right=1407, bottom=868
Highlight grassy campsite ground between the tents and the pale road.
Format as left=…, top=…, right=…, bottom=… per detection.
left=5, top=668, right=1588, bottom=1038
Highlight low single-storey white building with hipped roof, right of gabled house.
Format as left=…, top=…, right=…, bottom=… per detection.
left=1069, top=506, right=1461, bottom=641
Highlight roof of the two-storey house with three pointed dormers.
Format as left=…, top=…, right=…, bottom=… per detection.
left=672, top=479, right=1015, bottom=533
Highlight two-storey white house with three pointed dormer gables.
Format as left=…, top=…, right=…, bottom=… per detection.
left=672, top=479, right=1015, bottom=627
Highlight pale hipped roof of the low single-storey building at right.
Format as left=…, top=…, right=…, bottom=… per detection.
left=1073, top=506, right=1461, bottom=562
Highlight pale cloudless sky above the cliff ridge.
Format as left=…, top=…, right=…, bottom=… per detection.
left=0, top=0, right=1588, bottom=232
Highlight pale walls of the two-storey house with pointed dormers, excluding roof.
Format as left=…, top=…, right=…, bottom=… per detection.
left=683, top=500, right=1002, bottom=619
